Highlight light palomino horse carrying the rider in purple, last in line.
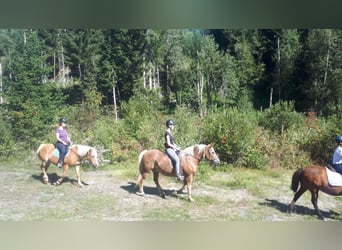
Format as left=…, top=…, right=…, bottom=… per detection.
left=37, top=144, right=99, bottom=186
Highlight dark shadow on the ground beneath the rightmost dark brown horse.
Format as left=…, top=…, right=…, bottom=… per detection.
left=259, top=199, right=339, bottom=218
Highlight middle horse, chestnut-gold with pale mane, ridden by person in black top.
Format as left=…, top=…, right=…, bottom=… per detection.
left=137, top=144, right=220, bottom=201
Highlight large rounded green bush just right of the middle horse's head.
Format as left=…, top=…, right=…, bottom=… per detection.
left=203, top=109, right=267, bottom=169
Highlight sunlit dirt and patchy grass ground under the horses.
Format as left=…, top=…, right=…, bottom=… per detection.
left=0, top=167, right=342, bottom=221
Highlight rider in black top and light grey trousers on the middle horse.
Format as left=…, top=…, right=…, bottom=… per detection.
left=164, top=119, right=184, bottom=181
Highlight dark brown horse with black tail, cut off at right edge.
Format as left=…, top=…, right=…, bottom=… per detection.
left=290, top=165, right=342, bottom=220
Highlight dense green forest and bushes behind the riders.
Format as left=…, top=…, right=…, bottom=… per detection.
left=0, top=29, right=342, bottom=169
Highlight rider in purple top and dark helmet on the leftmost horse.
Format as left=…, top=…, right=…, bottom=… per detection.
left=56, top=118, right=71, bottom=168
